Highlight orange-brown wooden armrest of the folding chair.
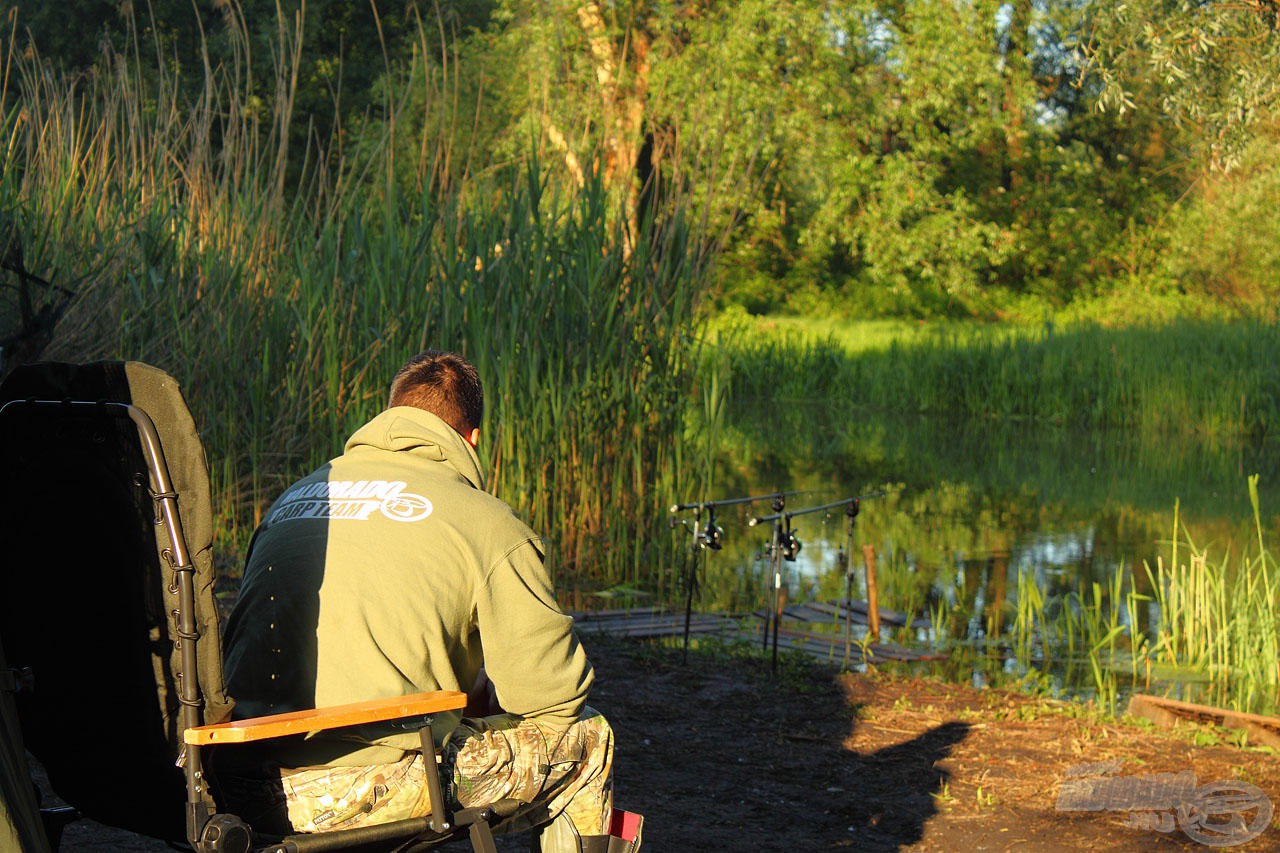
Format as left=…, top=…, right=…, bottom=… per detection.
left=182, top=690, right=467, bottom=747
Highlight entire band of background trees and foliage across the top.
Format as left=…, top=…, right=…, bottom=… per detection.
left=2, top=0, right=1280, bottom=315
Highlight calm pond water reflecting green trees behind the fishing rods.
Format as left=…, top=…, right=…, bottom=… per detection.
left=680, top=403, right=1280, bottom=711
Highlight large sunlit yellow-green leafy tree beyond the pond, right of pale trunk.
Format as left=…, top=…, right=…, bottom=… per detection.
left=663, top=0, right=1097, bottom=313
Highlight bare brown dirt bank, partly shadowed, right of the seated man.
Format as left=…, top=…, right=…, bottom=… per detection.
left=63, top=635, right=1280, bottom=852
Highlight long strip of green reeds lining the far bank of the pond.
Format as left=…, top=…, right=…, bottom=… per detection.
left=717, top=320, right=1280, bottom=441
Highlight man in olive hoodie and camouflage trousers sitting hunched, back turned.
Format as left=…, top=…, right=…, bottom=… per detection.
left=215, top=351, right=624, bottom=852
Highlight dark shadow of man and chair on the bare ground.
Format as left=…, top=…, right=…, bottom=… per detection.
left=586, top=638, right=969, bottom=850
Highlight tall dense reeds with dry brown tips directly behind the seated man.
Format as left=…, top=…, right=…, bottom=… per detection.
left=0, top=14, right=703, bottom=585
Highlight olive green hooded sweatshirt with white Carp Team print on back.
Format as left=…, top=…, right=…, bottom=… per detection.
left=225, top=406, right=594, bottom=766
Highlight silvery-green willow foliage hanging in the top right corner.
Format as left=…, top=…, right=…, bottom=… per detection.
left=1089, top=0, right=1280, bottom=308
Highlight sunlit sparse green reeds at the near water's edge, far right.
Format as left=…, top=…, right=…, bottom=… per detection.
left=1010, top=476, right=1280, bottom=713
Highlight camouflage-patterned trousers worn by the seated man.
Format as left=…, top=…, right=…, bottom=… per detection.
left=267, top=708, right=613, bottom=850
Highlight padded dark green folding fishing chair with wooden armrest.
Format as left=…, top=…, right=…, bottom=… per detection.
left=0, top=362, right=495, bottom=853
